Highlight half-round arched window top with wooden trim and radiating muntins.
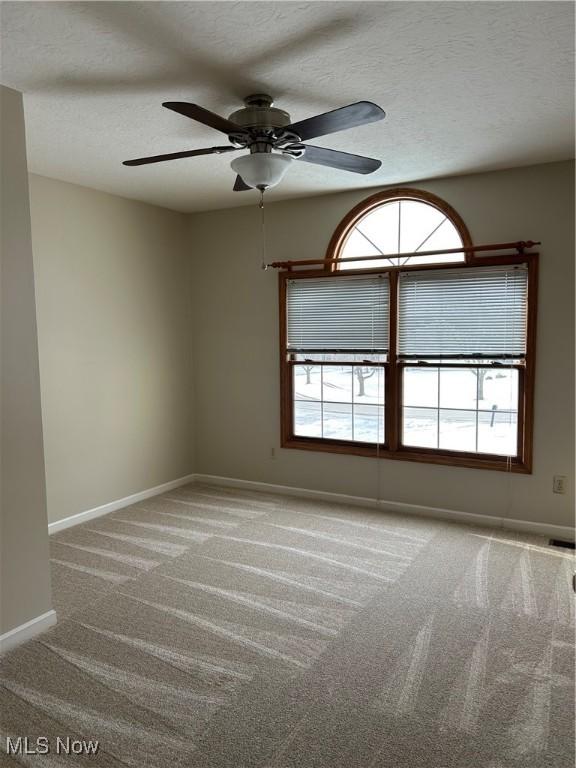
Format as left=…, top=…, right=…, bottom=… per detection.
left=327, top=188, right=472, bottom=270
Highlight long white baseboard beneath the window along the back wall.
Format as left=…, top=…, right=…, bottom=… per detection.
left=195, top=474, right=574, bottom=541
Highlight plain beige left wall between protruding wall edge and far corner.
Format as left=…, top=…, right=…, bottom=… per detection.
left=30, top=176, right=193, bottom=521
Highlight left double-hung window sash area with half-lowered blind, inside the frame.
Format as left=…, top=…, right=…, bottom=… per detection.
left=286, top=274, right=390, bottom=444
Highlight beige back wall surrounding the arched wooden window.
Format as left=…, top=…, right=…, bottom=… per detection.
left=189, top=158, right=574, bottom=525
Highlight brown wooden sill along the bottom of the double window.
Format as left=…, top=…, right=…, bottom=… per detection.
left=281, top=436, right=532, bottom=474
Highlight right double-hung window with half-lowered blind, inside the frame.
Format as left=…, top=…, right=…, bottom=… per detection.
left=398, top=264, right=528, bottom=457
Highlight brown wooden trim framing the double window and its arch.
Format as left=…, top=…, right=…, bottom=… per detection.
left=278, top=188, right=538, bottom=474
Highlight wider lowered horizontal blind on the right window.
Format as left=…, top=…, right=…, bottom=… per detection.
left=398, top=265, right=528, bottom=360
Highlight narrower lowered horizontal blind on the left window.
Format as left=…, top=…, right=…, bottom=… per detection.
left=287, top=275, right=390, bottom=352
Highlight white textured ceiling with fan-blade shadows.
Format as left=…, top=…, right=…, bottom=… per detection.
left=1, top=1, right=574, bottom=211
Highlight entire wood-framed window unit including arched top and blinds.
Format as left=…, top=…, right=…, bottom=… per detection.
left=280, top=190, right=537, bottom=472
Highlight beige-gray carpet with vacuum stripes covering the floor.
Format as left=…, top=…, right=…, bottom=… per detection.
left=0, top=485, right=574, bottom=768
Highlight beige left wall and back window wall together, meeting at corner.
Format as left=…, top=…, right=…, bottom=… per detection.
left=31, top=163, right=574, bottom=525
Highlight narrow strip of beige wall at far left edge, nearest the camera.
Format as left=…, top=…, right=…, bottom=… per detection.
left=0, top=86, right=51, bottom=635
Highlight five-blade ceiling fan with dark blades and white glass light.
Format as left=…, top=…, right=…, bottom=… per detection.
left=123, top=93, right=386, bottom=192
